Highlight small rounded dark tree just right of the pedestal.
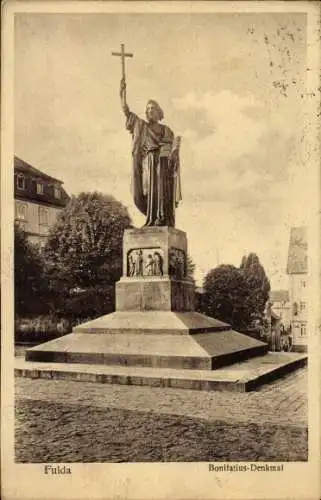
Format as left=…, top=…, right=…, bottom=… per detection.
left=203, top=264, right=249, bottom=329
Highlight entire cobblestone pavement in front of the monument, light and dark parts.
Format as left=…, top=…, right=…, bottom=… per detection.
left=15, top=368, right=308, bottom=463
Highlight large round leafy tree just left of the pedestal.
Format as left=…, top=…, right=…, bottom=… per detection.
left=44, top=192, right=131, bottom=317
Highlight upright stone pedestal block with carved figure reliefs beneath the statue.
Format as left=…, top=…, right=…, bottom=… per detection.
left=116, top=227, right=194, bottom=311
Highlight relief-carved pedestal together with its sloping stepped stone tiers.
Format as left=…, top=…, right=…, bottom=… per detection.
left=26, top=227, right=268, bottom=377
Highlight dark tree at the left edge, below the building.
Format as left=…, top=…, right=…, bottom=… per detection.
left=14, top=225, right=48, bottom=316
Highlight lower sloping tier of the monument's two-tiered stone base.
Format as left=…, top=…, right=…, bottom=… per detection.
left=26, top=329, right=267, bottom=370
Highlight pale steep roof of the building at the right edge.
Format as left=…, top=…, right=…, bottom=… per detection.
left=286, top=226, right=308, bottom=274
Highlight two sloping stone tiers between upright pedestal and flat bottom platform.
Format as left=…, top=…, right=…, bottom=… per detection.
left=26, top=312, right=268, bottom=370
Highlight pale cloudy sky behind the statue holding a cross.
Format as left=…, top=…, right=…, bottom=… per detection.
left=14, top=13, right=309, bottom=289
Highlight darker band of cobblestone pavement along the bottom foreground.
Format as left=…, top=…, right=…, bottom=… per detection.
left=15, top=399, right=307, bottom=463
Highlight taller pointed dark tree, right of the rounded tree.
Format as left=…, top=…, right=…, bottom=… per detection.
left=240, top=253, right=271, bottom=322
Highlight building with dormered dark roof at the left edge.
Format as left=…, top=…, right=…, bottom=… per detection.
left=14, top=156, right=70, bottom=246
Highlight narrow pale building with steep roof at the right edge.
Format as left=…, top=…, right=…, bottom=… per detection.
left=287, top=226, right=308, bottom=352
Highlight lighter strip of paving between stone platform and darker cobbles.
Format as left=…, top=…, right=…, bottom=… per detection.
left=16, top=368, right=307, bottom=427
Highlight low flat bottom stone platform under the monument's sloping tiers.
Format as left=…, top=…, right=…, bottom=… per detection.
left=15, top=352, right=307, bottom=392
